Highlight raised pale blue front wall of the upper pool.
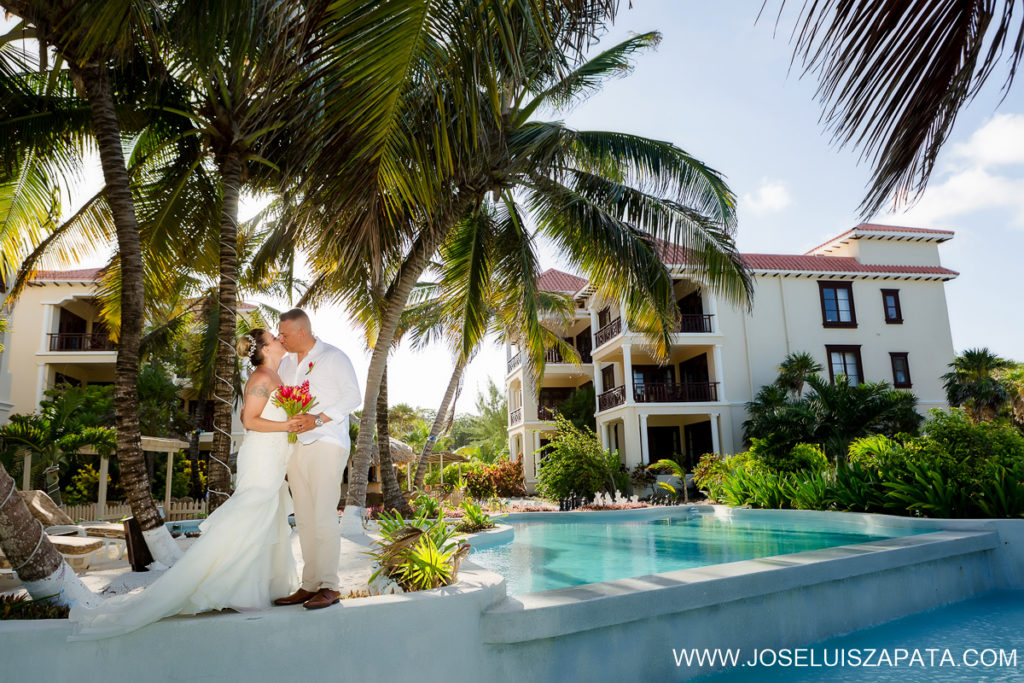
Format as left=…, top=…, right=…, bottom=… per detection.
left=480, top=530, right=999, bottom=644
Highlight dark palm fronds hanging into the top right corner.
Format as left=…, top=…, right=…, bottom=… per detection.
left=782, top=0, right=1024, bottom=216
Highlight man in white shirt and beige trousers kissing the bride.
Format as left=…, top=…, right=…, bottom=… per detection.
left=273, top=308, right=362, bottom=609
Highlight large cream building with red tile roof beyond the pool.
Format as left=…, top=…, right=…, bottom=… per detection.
left=505, top=223, right=957, bottom=487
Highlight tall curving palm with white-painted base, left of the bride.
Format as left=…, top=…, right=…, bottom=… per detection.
left=3, top=0, right=180, bottom=564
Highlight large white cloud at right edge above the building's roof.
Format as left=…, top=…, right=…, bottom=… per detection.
left=881, top=114, right=1024, bottom=227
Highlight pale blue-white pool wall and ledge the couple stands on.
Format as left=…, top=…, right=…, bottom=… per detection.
left=0, top=507, right=1024, bottom=683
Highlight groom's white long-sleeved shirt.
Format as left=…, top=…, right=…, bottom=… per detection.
left=278, top=339, right=362, bottom=453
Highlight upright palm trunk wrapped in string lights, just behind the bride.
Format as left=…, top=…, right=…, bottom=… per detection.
left=207, top=154, right=242, bottom=512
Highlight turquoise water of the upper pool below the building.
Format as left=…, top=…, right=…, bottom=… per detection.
left=471, top=509, right=915, bottom=594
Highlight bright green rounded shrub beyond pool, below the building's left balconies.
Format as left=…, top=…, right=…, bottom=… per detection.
left=537, top=415, right=620, bottom=500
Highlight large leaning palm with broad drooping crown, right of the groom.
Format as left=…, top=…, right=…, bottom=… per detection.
left=299, top=22, right=751, bottom=518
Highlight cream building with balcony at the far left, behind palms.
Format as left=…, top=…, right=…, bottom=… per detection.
left=0, top=268, right=243, bottom=449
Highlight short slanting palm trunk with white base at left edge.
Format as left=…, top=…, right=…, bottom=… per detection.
left=0, top=465, right=96, bottom=604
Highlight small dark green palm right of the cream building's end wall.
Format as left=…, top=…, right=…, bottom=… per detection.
left=942, top=348, right=1014, bottom=424
